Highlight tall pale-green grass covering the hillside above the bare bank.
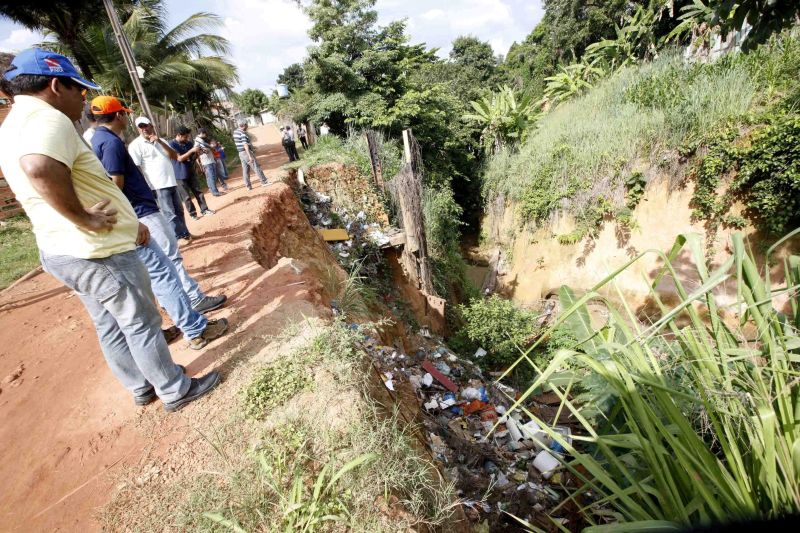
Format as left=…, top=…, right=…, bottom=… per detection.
left=484, top=35, right=800, bottom=220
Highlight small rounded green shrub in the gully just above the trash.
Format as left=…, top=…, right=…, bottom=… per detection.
left=459, top=295, right=536, bottom=368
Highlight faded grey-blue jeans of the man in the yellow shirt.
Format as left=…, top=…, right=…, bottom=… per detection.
left=40, top=247, right=191, bottom=402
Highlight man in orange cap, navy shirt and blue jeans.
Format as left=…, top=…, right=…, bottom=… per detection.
left=91, top=96, right=228, bottom=358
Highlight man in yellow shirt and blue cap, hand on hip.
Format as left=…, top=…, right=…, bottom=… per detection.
left=0, top=48, right=220, bottom=411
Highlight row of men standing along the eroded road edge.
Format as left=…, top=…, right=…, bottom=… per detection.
left=0, top=48, right=241, bottom=411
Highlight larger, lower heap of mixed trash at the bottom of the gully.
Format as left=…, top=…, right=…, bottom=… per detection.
left=361, top=328, right=578, bottom=531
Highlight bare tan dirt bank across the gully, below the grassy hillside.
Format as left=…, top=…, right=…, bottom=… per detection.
left=484, top=175, right=789, bottom=315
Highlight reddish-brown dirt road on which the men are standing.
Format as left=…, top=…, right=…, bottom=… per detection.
left=0, top=123, right=319, bottom=531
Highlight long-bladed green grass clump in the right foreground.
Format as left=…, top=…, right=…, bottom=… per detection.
left=500, top=230, right=800, bottom=531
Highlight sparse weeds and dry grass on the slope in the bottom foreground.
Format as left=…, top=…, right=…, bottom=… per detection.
left=183, top=322, right=454, bottom=531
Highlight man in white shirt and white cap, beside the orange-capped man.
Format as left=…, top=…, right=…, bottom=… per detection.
left=128, top=117, right=192, bottom=242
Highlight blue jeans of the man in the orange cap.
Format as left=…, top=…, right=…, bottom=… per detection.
left=136, top=238, right=208, bottom=339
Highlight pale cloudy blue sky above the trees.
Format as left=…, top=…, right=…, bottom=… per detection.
left=0, top=0, right=543, bottom=91
